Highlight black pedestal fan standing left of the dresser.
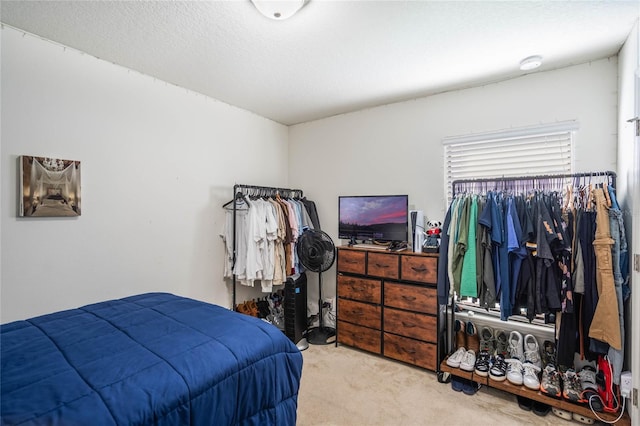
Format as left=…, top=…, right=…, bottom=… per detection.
left=296, top=229, right=336, bottom=345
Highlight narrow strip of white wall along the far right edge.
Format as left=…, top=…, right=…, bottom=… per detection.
left=618, top=22, right=640, bottom=425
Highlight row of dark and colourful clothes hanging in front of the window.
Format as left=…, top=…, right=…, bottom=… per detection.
left=438, top=172, right=628, bottom=383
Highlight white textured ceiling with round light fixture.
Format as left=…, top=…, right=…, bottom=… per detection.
left=0, top=0, right=640, bottom=125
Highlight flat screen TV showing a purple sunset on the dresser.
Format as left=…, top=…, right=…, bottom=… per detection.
left=338, top=195, right=409, bottom=243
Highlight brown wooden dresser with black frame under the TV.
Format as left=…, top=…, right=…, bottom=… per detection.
left=337, top=247, right=438, bottom=370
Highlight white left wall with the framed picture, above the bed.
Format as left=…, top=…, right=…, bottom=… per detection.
left=0, top=27, right=288, bottom=323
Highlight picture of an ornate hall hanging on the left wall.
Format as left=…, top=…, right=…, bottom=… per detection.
left=18, top=155, right=81, bottom=217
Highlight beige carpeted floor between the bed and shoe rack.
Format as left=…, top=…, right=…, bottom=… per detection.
left=297, top=344, right=580, bottom=426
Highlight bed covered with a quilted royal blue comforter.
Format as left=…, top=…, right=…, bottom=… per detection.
left=0, top=293, right=302, bottom=426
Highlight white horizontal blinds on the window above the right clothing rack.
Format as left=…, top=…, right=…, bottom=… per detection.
left=442, top=121, right=578, bottom=202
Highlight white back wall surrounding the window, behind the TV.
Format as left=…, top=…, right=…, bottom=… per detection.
left=289, top=58, right=617, bottom=309
